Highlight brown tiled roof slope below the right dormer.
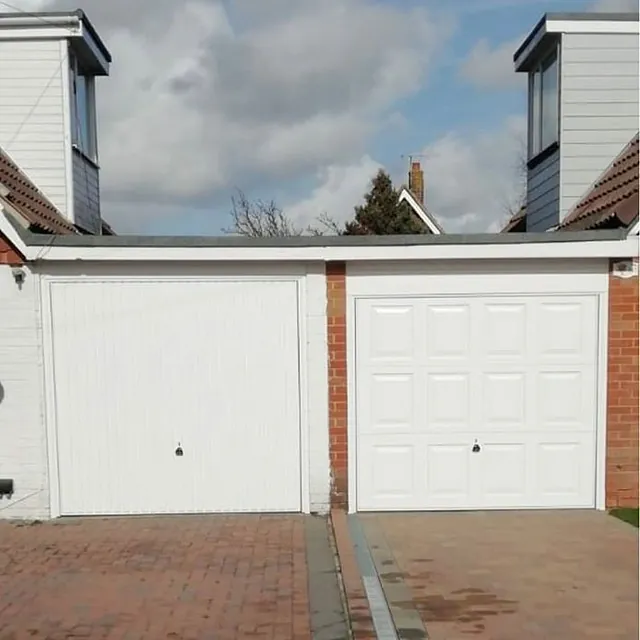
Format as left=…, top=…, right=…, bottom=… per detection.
left=557, top=134, right=640, bottom=231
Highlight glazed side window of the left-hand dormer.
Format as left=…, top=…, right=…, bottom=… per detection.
left=71, top=56, right=98, bottom=162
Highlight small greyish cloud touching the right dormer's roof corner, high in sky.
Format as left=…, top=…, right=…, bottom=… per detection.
left=460, top=36, right=525, bottom=89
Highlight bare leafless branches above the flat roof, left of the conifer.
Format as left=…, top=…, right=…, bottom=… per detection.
left=224, top=189, right=344, bottom=238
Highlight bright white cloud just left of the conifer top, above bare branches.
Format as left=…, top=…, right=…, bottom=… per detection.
left=284, top=155, right=381, bottom=227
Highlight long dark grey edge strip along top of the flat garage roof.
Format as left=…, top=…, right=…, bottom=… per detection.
left=17, top=229, right=627, bottom=249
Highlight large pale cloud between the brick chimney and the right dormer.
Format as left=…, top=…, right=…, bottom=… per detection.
left=422, top=116, right=526, bottom=233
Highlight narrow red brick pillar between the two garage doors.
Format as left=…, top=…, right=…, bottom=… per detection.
left=326, top=262, right=348, bottom=508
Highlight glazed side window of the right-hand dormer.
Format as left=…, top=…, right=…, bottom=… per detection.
left=529, top=51, right=559, bottom=159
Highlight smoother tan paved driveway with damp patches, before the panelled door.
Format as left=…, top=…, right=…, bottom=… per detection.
left=358, top=511, right=638, bottom=640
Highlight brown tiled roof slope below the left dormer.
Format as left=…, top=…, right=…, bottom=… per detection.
left=0, top=148, right=77, bottom=234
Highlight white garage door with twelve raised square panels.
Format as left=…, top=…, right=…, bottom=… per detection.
left=356, top=296, right=597, bottom=510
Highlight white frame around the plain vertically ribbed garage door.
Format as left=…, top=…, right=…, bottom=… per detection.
left=39, top=266, right=316, bottom=518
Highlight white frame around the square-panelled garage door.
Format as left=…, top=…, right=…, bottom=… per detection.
left=346, top=261, right=609, bottom=513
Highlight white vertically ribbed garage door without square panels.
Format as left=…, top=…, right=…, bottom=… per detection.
left=51, top=281, right=301, bottom=515
